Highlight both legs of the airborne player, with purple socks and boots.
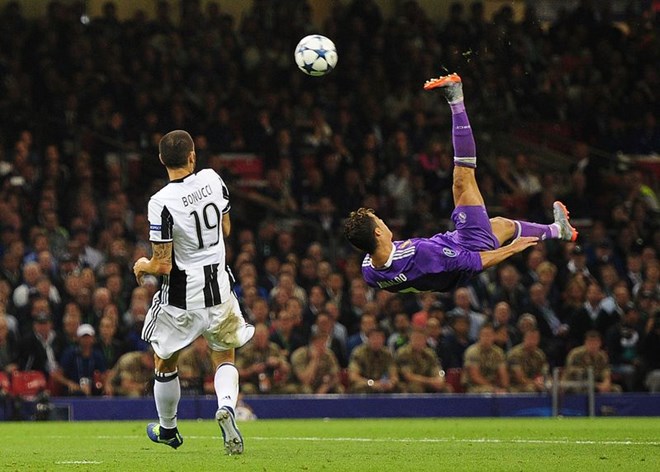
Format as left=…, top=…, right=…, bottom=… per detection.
left=424, top=74, right=577, bottom=245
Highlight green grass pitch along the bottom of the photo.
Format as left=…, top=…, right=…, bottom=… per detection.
left=0, top=418, right=660, bottom=472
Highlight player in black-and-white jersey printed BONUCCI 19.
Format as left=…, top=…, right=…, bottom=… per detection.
left=133, top=130, right=254, bottom=454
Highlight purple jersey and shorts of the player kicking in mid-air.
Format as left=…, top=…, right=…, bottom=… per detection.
left=362, top=206, right=499, bottom=292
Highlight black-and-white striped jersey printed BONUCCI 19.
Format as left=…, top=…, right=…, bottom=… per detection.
left=149, top=169, right=231, bottom=310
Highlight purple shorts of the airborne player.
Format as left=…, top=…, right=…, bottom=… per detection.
left=445, top=205, right=500, bottom=252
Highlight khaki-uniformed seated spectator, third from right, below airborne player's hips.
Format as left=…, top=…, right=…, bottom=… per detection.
left=461, top=323, right=509, bottom=393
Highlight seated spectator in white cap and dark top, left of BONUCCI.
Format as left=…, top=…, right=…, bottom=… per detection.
left=60, top=323, right=106, bottom=397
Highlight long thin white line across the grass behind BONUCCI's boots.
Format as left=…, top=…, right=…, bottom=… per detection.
left=43, top=434, right=660, bottom=446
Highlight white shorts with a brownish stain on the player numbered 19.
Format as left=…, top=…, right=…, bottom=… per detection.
left=142, top=293, right=254, bottom=359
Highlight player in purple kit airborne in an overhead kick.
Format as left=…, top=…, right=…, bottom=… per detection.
left=344, top=74, right=577, bottom=292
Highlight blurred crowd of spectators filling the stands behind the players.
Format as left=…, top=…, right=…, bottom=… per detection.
left=0, top=0, right=660, bottom=395
